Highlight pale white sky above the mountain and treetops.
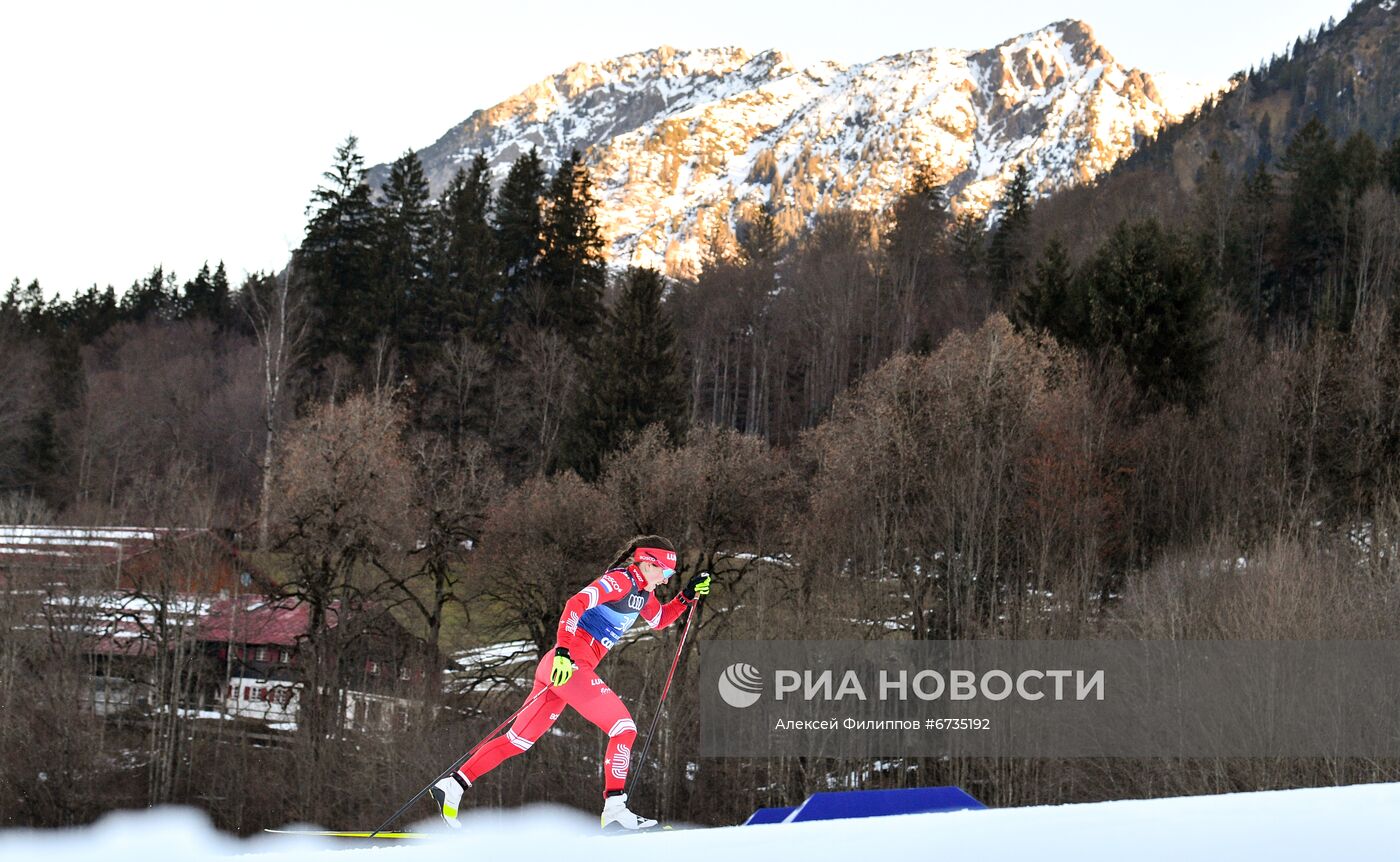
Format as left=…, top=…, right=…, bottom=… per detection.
left=0, top=0, right=1351, bottom=295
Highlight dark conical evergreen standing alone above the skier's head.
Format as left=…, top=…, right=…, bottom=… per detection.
left=564, top=269, right=686, bottom=479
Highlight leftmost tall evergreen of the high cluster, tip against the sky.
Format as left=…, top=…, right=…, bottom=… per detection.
left=294, top=134, right=389, bottom=362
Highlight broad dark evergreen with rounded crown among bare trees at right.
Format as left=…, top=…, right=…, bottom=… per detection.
left=1085, top=220, right=1212, bottom=404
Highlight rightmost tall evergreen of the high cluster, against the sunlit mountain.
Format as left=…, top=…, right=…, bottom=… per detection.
left=539, top=150, right=608, bottom=347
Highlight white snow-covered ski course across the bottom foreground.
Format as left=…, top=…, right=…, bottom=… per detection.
left=0, top=784, right=1400, bottom=862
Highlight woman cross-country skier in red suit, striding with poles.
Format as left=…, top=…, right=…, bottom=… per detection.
left=430, top=536, right=710, bottom=830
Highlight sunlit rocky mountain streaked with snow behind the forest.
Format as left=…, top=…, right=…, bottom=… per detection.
left=371, top=21, right=1204, bottom=271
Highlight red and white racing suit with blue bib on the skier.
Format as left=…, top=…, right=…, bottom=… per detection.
left=461, top=565, right=694, bottom=796
